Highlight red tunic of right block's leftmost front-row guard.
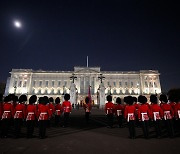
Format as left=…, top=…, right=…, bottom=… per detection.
left=124, top=105, right=136, bottom=122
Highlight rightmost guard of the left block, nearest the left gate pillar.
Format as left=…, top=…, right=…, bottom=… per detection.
left=62, top=94, right=72, bottom=127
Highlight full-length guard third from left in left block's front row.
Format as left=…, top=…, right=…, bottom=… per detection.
left=25, top=95, right=37, bottom=138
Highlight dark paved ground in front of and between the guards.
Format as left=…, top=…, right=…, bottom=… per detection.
left=0, top=109, right=180, bottom=154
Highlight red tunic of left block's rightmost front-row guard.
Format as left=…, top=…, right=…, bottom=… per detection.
left=37, top=104, right=51, bottom=120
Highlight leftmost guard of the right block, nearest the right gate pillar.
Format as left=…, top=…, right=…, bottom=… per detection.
left=105, top=95, right=115, bottom=128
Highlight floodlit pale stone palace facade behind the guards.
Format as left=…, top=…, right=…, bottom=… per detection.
left=5, top=67, right=161, bottom=104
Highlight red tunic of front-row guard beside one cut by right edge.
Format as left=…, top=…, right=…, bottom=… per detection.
left=161, top=103, right=174, bottom=120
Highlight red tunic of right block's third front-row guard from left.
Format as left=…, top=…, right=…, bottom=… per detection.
left=151, top=104, right=163, bottom=121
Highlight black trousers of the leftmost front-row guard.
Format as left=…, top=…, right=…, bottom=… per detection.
left=1, top=119, right=11, bottom=137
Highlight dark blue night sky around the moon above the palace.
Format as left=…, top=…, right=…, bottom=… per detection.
left=0, top=0, right=180, bottom=91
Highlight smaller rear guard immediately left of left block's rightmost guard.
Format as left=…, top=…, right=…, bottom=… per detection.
left=55, top=97, right=62, bottom=126
